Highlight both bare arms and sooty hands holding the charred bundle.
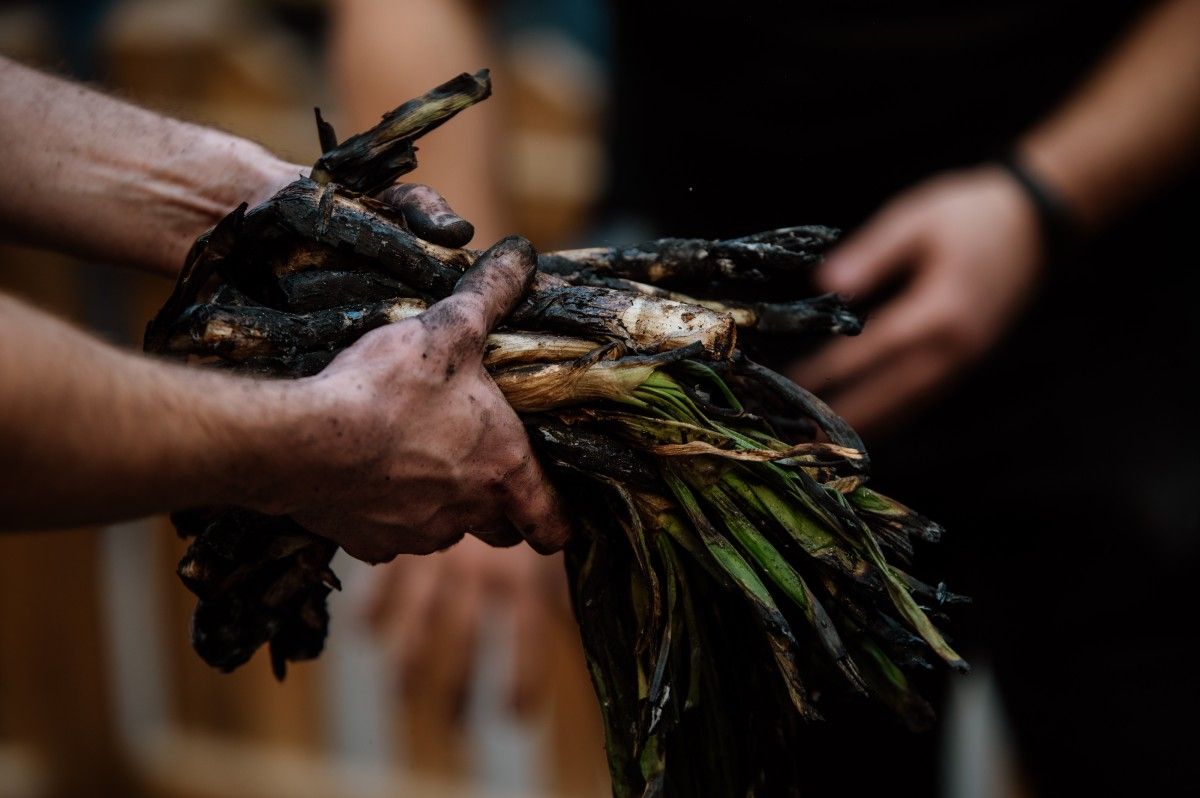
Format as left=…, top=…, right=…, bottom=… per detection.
left=0, top=59, right=566, bottom=562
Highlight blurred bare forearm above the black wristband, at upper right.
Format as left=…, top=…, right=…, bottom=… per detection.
left=1019, top=0, right=1200, bottom=229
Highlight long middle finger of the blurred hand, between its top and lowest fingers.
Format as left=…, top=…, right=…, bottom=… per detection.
left=787, top=289, right=932, bottom=394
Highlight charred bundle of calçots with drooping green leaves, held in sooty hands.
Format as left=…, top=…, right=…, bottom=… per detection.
left=145, top=72, right=965, bottom=796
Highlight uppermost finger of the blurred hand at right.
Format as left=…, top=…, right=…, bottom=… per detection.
left=814, top=202, right=923, bottom=298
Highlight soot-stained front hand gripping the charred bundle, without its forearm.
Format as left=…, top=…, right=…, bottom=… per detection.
left=274, top=238, right=568, bottom=563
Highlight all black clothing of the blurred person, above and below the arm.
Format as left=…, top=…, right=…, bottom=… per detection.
left=612, top=0, right=1200, bottom=796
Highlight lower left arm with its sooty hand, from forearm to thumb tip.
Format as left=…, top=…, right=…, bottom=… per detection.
left=0, top=238, right=568, bottom=562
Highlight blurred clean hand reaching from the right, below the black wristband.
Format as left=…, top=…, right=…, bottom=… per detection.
left=788, top=167, right=1043, bottom=433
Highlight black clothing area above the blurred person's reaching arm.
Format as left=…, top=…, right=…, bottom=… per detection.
left=613, top=0, right=1138, bottom=235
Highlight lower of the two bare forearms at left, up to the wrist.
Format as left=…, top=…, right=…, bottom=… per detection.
left=0, top=294, right=311, bottom=528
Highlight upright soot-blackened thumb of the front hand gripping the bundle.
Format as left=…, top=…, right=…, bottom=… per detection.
left=416, top=235, right=538, bottom=362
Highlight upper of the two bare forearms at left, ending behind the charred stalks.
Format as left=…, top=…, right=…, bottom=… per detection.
left=0, top=58, right=296, bottom=275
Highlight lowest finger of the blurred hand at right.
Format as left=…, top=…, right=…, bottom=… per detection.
left=830, top=344, right=954, bottom=434
